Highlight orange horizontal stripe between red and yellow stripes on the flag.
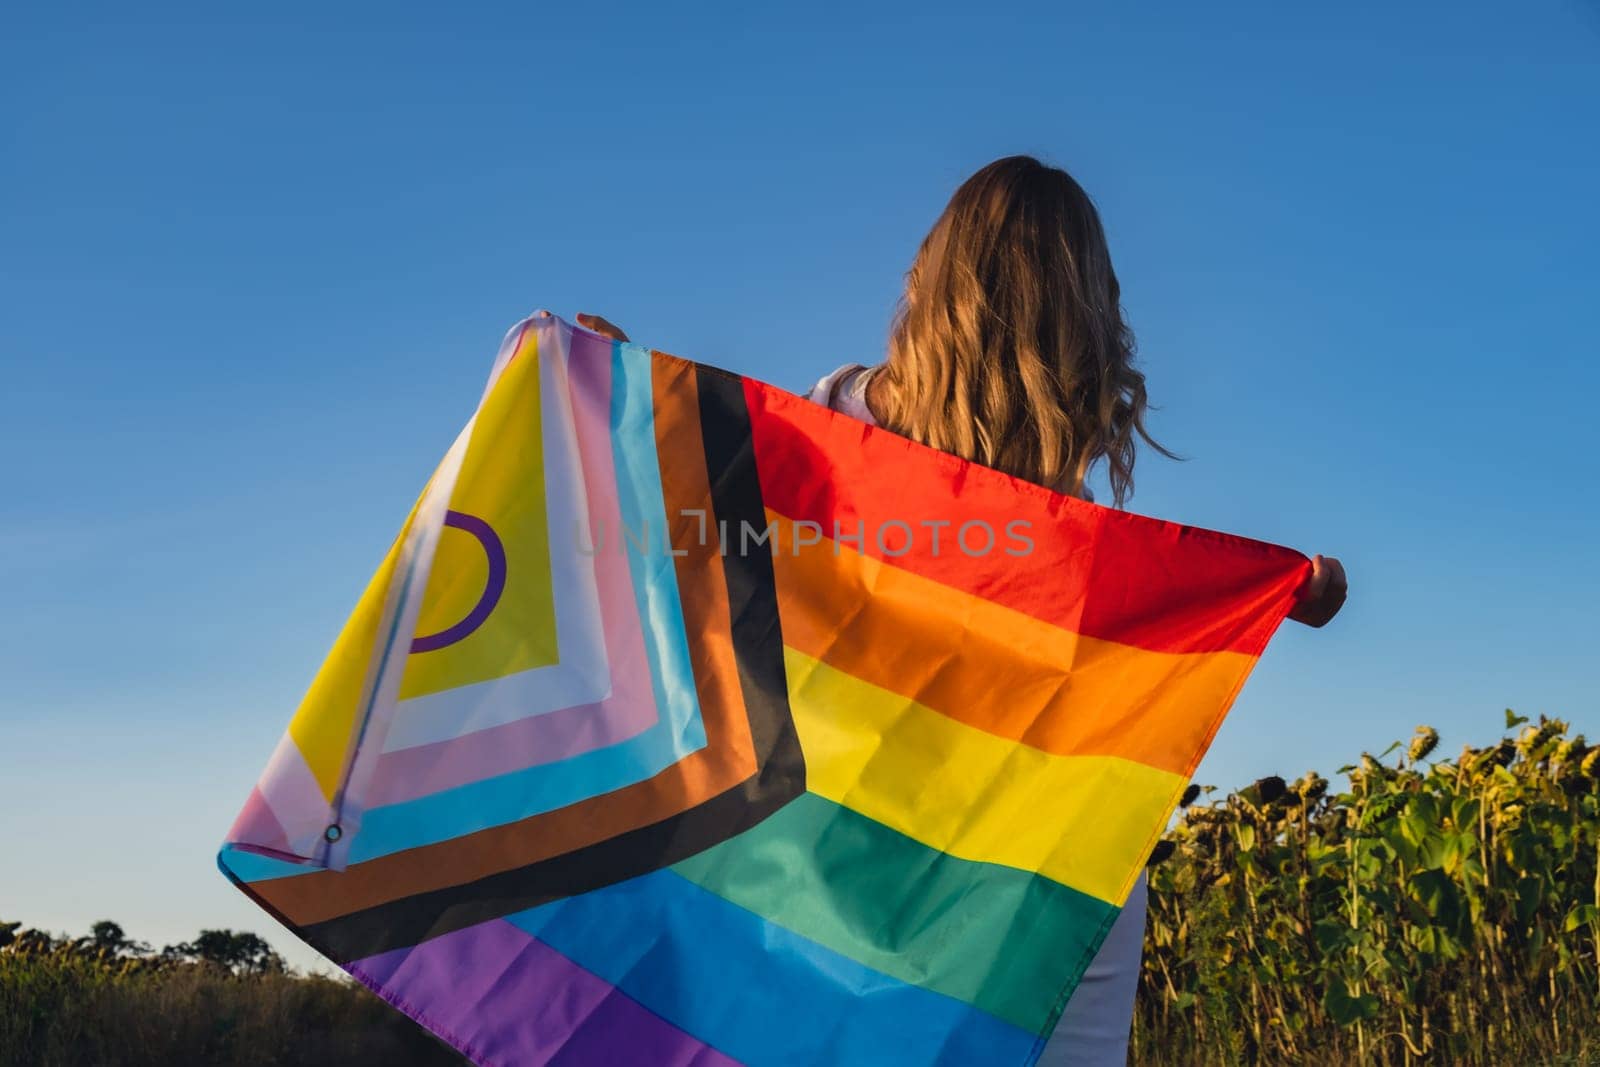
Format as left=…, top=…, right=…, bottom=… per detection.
left=768, top=510, right=1256, bottom=776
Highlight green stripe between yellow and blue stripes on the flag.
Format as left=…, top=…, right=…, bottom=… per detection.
left=672, top=793, right=1118, bottom=1033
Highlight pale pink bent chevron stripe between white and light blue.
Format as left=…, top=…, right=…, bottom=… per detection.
left=366, top=333, right=658, bottom=808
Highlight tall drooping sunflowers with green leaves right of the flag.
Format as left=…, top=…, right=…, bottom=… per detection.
left=1134, top=710, right=1600, bottom=1067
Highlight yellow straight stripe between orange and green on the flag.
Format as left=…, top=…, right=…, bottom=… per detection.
left=784, top=648, right=1186, bottom=905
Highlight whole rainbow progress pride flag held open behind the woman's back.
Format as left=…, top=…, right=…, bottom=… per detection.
left=219, top=317, right=1309, bottom=1067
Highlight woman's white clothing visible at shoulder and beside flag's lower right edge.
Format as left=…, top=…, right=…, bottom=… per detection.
left=808, top=363, right=1147, bottom=1067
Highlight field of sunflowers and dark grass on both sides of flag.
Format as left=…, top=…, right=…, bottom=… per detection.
left=0, top=712, right=1600, bottom=1067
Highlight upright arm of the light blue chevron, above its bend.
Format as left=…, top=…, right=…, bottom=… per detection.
left=611, top=342, right=706, bottom=758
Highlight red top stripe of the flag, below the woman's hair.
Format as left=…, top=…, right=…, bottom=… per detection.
left=746, top=379, right=1310, bottom=656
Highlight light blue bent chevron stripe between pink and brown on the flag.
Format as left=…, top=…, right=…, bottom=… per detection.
left=289, top=346, right=706, bottom=864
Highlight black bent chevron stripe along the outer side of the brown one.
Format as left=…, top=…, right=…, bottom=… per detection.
left=299, top=366, right=805, bottom=961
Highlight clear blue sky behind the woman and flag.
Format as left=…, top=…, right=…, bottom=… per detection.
left=0, top=0, right=1600, bottom=963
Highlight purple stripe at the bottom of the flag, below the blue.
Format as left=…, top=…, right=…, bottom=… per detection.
left=346, top=918, right=738, bottom=1067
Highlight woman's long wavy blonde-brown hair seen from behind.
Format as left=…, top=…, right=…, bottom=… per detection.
left=869, top=155, right=1171, bottom=507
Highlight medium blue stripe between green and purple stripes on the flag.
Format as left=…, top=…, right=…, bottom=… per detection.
left=507, top=870, right=1037, bottom=1067
